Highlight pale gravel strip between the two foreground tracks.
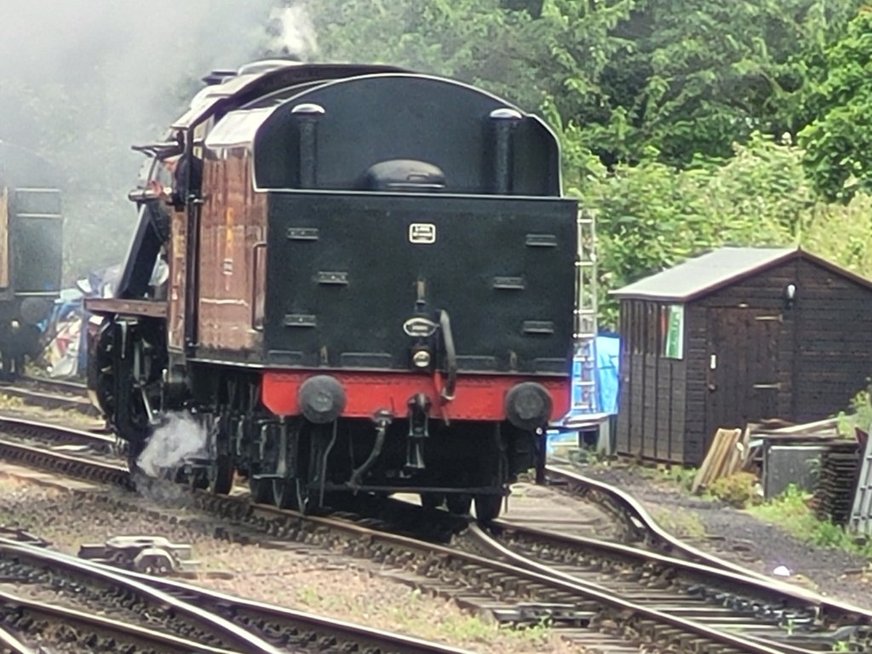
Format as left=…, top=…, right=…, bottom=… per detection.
left=0, top=477, right=578, bottom=654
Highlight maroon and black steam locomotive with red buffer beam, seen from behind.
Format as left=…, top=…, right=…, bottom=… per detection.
left=87, top=61, right=577, bottom=521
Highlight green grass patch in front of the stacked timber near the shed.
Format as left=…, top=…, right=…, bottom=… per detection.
left=748, top=485, right=872, bottom=559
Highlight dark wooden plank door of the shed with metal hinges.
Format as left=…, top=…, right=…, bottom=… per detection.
left=706, top=308, right=789, bottom=442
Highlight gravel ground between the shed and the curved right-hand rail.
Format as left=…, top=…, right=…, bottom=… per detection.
left=579, top=463, right=872, bottom=608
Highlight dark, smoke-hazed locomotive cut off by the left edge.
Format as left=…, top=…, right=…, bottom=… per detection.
left=0, top=141, right=63, bottom=379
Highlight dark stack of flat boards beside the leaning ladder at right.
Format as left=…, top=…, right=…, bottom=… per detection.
left=812, top=440, right=860, bottom=525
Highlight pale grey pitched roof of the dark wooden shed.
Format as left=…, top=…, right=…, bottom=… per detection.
left=612, top=247, right=872, bottom=302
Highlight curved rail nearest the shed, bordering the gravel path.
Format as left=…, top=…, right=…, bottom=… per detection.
left=546, top=465, right=872, bottom=624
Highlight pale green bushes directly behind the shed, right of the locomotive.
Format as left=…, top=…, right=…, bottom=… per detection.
left=584, top=137, right=814, bottom=325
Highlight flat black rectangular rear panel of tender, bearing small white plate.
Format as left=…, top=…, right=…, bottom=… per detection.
left=264, top=192, right=576, bottom=375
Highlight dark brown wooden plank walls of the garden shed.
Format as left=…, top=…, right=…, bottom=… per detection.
left=617, top=255, right=872, bottom=465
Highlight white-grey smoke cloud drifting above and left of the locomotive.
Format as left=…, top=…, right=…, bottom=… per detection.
left=0, top=0, right=316, bottom=282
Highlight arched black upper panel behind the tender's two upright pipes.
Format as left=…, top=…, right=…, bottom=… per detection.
left=254, top=74, right=560, bottom=196
